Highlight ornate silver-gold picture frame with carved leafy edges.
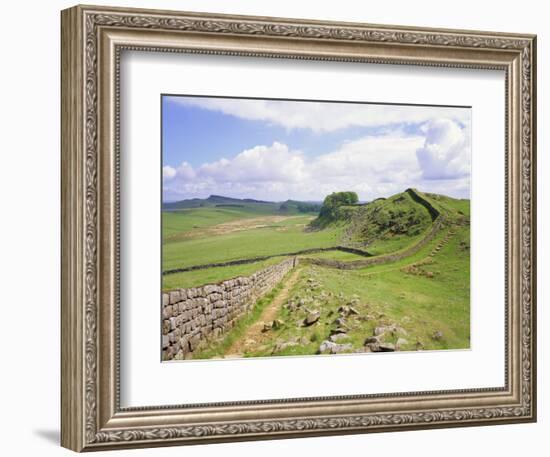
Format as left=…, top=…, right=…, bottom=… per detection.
left=61, top=6, right=536, bottom=451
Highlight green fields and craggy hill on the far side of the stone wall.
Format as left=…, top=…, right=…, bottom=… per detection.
left=162, top=190, right=469, bottom=288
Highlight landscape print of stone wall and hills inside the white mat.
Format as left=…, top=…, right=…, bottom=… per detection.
left=161, top=94, right=471, bottom=361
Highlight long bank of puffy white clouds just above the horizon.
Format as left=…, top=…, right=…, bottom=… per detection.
left=164, top=119, right=470, bottom=201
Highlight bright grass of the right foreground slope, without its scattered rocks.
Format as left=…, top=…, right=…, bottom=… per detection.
left=229, top=221, right=470, bottom=356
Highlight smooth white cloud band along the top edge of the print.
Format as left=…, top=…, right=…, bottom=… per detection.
left=172, top=97, right=470, bottom=132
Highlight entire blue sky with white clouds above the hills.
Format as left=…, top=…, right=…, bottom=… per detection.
left=162, top=96, right=471, bottom=202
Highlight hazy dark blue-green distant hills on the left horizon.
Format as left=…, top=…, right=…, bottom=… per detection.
left=162, top=195, right=321, bottom=214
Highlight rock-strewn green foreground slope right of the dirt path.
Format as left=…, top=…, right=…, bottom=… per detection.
left=195, top=222, right=470, bottom=358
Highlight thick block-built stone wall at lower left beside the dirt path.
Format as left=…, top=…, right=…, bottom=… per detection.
left=162, top=257, right=298, bottom=360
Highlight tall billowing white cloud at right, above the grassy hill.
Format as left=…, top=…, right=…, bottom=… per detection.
left=416, top=119, right=470, bottom=179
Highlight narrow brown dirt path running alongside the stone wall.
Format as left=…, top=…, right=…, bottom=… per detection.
left=224, top=268, right=300, bottom=358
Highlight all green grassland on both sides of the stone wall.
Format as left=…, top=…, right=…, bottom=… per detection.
left=162, top=192, right=470, bottom=358
